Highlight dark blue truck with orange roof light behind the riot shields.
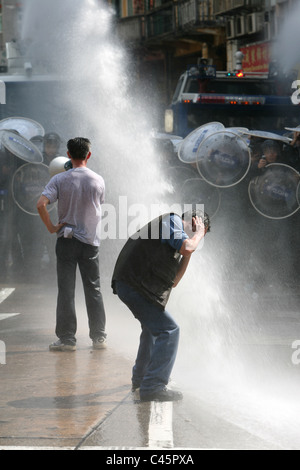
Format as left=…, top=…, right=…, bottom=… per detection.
left=165, top=60, right=300, bottom=138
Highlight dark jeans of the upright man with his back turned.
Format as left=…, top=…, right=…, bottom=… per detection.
left=56, top=237, right=106, bottom=344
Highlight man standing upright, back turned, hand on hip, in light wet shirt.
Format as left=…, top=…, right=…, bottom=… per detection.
left=37, top=137, right=106, bottom=351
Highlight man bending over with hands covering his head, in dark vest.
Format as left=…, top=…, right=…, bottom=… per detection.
left=112, top=211, right=210, bottom=401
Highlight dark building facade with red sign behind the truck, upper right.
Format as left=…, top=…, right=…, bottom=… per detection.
left=111, top=0, right=299, bottom=102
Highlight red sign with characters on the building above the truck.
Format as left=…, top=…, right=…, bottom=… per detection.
left=240, top=42, right=270, bottom=72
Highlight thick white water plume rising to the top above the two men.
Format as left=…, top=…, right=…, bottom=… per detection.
left=21, top=0, right=167, bottom=210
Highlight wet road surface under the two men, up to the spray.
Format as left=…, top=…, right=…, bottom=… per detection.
left=0, top=282, right=298, bottom=450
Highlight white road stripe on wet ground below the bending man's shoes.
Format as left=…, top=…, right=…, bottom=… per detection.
left=148, top=401, right=174, bottom=449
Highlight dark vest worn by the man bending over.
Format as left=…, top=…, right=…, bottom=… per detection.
left=112, top=214, right=181, bottom=309
